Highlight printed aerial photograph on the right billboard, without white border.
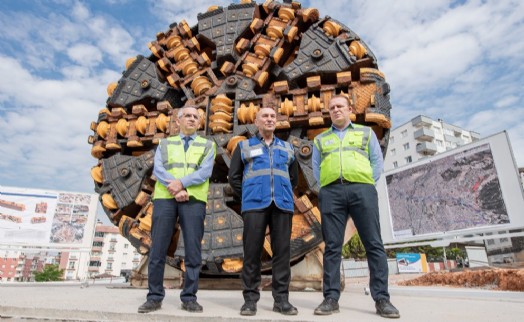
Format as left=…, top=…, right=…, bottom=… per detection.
left=386, top=144, right=509, bottom=237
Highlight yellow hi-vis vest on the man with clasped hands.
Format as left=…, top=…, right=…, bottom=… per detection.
left=153, top=135, right=215, bottom=202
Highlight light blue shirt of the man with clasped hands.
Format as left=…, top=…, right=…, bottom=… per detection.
left=153, top=133, right=215, bottom=188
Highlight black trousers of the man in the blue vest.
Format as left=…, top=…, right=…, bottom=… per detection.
left=241, top=203, right=293, bottom=302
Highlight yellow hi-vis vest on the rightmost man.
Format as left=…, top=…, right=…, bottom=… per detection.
left=315, top=124, right=375, bottom=187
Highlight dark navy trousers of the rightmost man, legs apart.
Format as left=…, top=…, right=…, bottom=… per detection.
left=319, top=183, right=389, bottom=301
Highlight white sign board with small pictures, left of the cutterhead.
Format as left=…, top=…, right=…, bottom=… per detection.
left=0, top=186, right=98, bottom=249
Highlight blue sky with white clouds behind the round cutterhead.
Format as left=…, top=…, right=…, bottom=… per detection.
left=0, top=0, right=524, bottom=221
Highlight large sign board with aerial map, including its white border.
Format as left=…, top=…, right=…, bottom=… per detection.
left=377, top=132, right=524, bottom=244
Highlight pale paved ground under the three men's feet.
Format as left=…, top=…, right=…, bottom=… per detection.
left=0, top=278, right=524, bottom=322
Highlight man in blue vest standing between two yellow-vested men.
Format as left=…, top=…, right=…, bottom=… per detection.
left=229, top=107, right=298, bottom=315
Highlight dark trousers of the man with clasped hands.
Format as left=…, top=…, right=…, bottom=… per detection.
left=147, top=199, right=206, bottom=302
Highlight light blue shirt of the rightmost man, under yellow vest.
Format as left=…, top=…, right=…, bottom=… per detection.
left=312, top=122, right=384, bottom=183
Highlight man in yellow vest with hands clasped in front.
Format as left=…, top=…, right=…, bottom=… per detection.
left=138, top=105, right=216, bottom=313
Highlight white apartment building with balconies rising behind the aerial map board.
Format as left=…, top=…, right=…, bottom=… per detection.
left=384, top=115, right=480, bottom=171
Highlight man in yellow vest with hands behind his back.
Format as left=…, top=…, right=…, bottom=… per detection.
left=313, top=95, right=400, bottom=318
